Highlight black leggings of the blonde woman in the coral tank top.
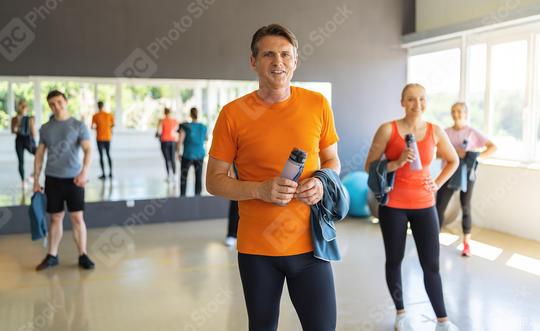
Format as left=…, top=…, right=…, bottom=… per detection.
left=379, top=206, right=446, bottom=317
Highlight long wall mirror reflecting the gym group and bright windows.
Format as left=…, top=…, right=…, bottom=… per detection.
left=0, top=76, right=332, bottom=206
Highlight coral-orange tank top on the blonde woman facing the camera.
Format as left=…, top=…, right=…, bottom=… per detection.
left=384, top=121, right=435, bottom=209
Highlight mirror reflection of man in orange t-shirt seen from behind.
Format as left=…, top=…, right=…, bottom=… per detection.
left=92, top=101, right=114, bottom=179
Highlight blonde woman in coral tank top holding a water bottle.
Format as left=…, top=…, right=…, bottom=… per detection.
left=366, top=84, right=459, bottom=331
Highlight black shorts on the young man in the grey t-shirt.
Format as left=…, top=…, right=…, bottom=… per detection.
left=45, top=176, right=84, bottom=214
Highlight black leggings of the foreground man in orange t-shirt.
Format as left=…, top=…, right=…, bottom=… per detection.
left=238, top=252, right=336, bottom=331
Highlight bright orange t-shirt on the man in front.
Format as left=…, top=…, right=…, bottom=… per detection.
left=209, top=87, right=339, bottom=256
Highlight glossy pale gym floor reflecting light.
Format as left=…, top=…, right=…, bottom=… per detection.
left=0, top=219, right=540, bottom=331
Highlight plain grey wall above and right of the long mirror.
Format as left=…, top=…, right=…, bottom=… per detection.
left=0, top=0, right=414, bottom=175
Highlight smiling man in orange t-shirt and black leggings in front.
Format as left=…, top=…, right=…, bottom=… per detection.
left=207, top=24, right=340, bottom=330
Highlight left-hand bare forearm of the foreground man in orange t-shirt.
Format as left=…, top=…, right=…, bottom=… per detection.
left=207, top=174, right=261, bottom=201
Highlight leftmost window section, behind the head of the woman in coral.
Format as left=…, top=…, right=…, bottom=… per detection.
left=408, top=48, right=460, bottom=126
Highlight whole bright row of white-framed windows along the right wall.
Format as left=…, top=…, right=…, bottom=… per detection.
left=406, top=23, right=540, bottom=162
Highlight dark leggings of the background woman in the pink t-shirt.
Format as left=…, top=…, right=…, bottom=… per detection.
left=437, top=180, right=475, bottom=234
